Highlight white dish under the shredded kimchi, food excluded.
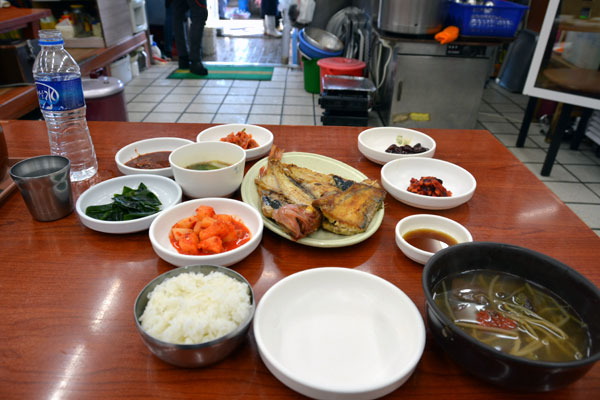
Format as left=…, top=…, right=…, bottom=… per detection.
left=196, top=124, right=273, bottom=161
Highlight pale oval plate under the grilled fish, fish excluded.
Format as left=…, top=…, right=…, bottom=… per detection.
left=241, top=152, right=384, bottom=247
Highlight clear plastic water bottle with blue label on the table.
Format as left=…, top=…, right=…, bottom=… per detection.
left=33, top=30, right=98, bottom=181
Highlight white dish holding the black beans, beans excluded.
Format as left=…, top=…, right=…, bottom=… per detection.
left=358, top=126, right=436, bottom=165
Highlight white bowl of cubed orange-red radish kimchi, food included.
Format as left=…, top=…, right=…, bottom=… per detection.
left=149, top=197, right=263, bottom=267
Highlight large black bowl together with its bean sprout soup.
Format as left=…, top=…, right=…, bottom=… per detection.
left=422, top=242, right=600, bottom=392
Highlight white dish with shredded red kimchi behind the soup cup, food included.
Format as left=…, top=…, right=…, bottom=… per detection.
left=196, top=124, right=273, bottom=161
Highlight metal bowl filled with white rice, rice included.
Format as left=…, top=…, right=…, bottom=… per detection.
left=133, top=265, right=256, bottom=368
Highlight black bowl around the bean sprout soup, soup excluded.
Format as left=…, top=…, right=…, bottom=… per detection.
left=422, top=242, right=600, bottom=391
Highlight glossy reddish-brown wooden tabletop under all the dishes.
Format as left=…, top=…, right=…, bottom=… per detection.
left=0, top=121, right=600, bottom=400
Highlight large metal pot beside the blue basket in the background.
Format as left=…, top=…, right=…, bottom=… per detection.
left=377, top=0, right=445, bottom=35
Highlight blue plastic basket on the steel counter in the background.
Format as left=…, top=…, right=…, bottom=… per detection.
left=446, top=0, right=529, bottom=37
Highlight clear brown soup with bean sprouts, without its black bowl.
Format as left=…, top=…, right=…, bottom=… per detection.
left=433, top=270, right=591, bottom=362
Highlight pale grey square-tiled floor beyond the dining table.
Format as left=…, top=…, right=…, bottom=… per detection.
left=125, top=63, right=600, bottom=236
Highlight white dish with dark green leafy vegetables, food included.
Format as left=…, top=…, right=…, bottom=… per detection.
left=75, top=174, right=182, bottom=233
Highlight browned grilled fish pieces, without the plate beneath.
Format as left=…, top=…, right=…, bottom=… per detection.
left=255, top=146, right=386, bottom=240
